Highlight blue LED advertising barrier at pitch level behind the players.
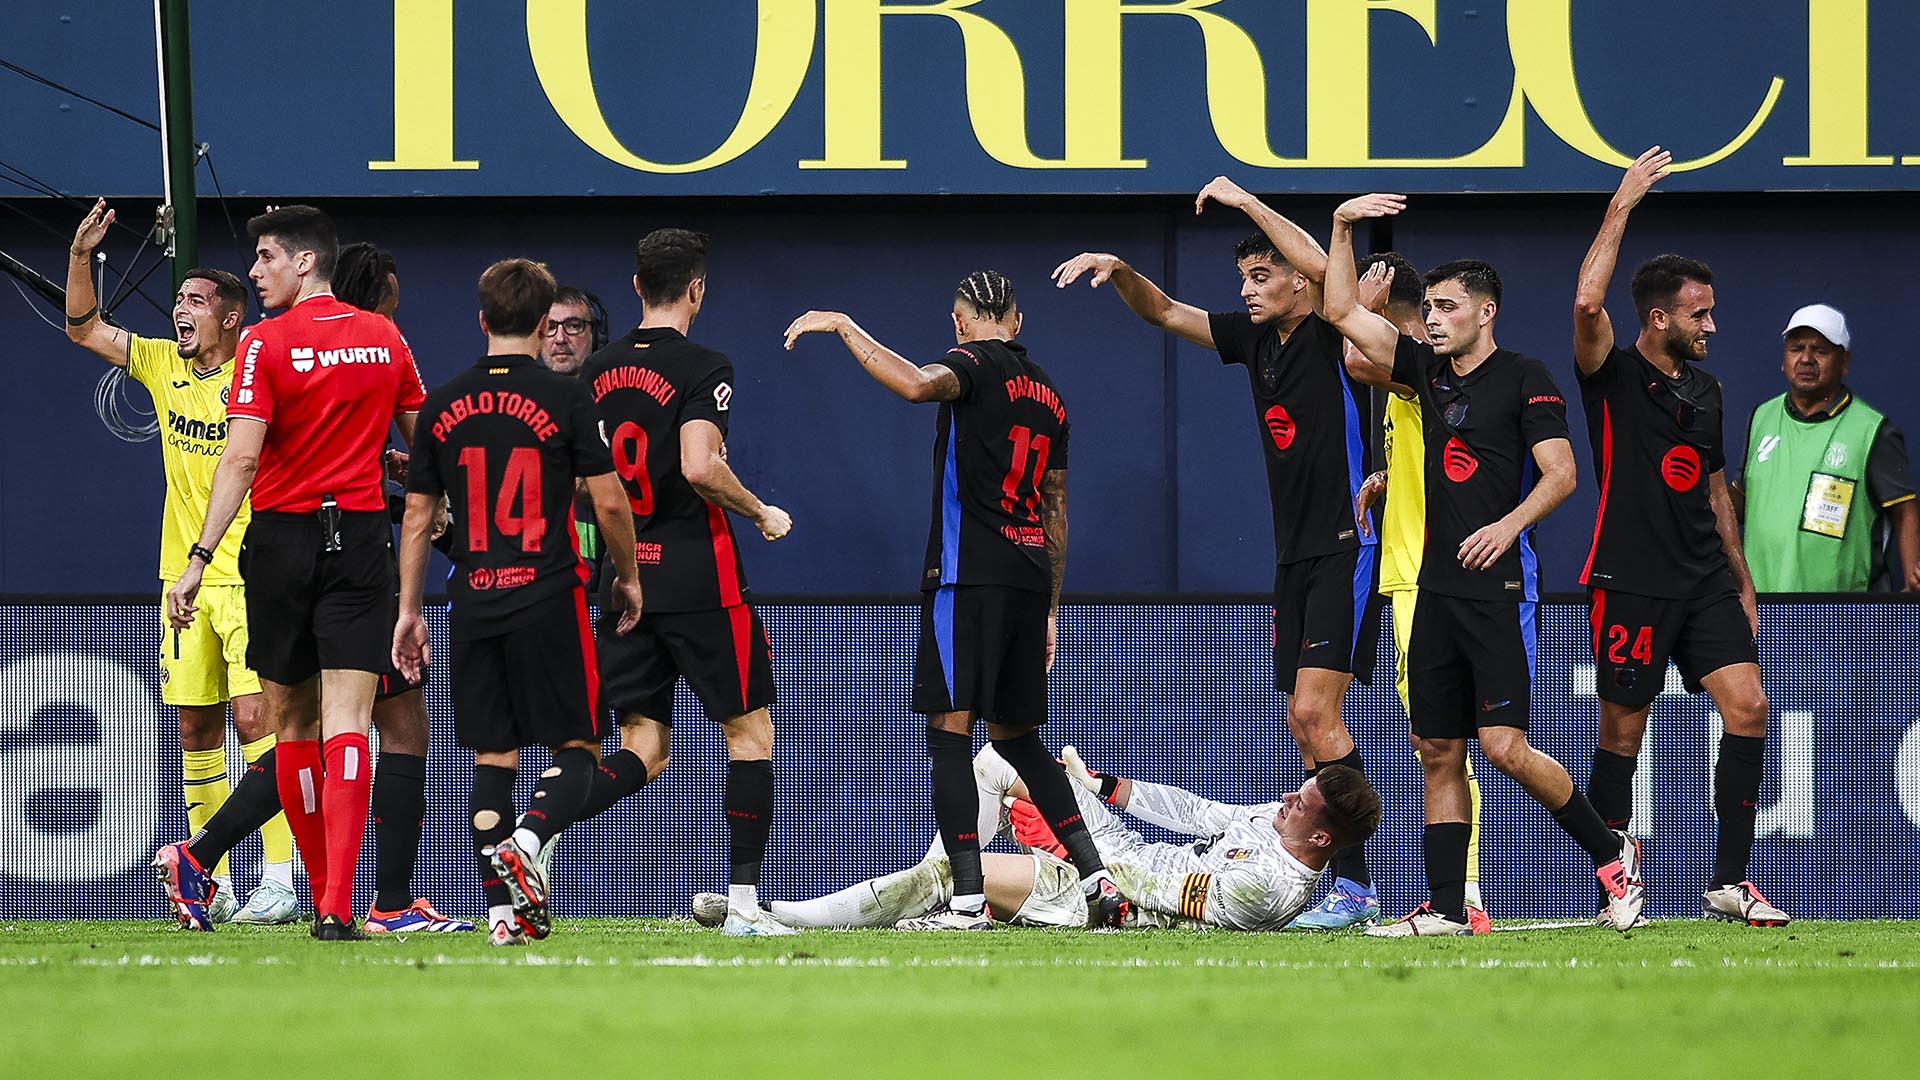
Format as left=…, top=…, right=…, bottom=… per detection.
left=0, top=600, right=1920, bottom=919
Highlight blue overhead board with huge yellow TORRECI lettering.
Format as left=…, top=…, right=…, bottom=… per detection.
left=11, top=0, right=1920, bottom=196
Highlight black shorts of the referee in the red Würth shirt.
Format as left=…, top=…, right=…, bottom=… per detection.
left=240, top=511, right=397, bottom=684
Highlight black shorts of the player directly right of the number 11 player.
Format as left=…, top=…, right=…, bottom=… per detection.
left=1273, top=544, right=1382, bottom=694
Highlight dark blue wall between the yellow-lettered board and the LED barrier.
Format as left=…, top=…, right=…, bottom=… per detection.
left=0, top=196, right=1920, bottom=594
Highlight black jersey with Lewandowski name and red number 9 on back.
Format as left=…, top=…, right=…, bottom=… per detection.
left=580, top=327, right=747, bottom=611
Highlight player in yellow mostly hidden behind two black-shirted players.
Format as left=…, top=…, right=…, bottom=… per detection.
left=1346, top=252, right=1484, bottom=914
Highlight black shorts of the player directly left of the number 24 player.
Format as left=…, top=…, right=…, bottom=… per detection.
left=1407, top=588, right=1540, bottom=738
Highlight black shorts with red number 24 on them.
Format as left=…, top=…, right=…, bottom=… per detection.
left=1586, top=588, right=1761, bottom=709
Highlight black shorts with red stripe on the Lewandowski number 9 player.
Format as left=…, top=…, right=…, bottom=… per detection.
left=599, top=603, right=776, bottom=726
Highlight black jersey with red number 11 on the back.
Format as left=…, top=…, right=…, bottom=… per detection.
left=920, top=340, right=1069, bottom=592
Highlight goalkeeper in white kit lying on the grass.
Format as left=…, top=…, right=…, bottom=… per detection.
left=693, top=746, right=1380, bottom=930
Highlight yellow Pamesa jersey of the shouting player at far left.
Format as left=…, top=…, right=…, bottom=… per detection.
left=127, top=334, right=252, bottom=584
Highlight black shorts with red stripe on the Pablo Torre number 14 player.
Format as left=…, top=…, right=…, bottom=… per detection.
left=451, top=588, right=601, bottom=753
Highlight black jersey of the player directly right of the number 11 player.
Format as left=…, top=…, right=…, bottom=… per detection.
left=1208, top=311, right=1380, bottom=563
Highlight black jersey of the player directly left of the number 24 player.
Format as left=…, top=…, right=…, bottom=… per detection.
left=1394, top=334, right=1567, bottom=603
